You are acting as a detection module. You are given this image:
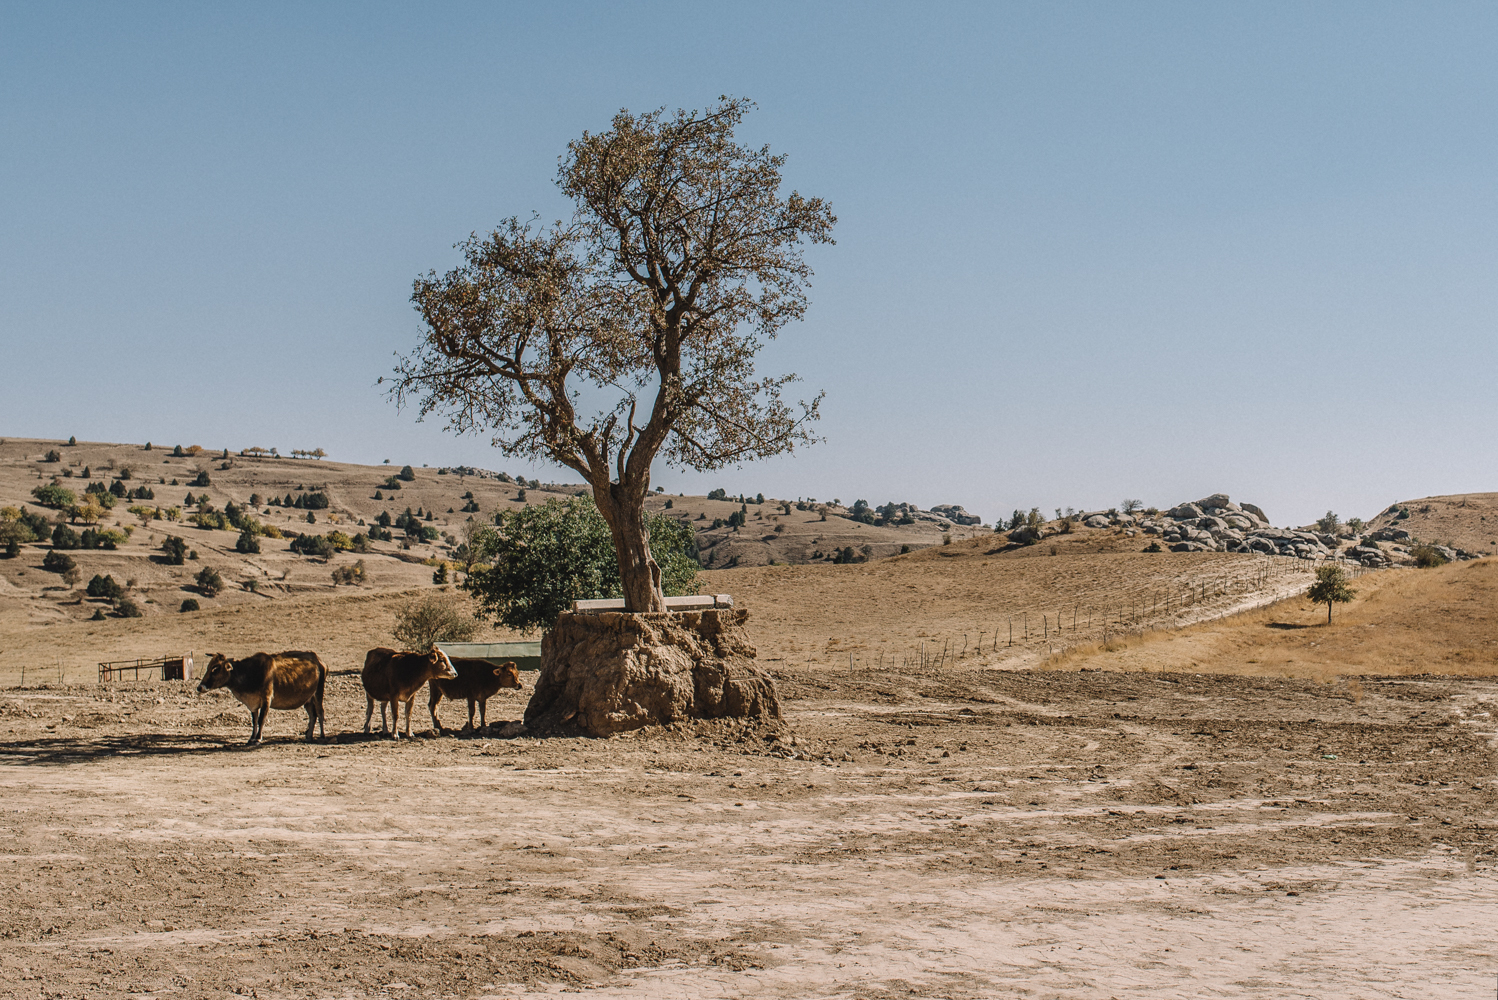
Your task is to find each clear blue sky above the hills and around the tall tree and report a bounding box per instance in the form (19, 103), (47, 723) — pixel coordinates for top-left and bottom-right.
(0, 3), (1498, 524)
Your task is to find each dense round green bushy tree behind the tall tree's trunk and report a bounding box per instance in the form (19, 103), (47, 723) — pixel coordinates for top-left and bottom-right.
(463, 496), (698, 632)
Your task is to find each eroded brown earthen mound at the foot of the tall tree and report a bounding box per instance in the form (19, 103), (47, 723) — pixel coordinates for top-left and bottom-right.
(526, 609), (780, 737)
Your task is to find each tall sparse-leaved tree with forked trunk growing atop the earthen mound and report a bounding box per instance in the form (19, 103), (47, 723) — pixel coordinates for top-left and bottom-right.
(392, 97), (836, 611)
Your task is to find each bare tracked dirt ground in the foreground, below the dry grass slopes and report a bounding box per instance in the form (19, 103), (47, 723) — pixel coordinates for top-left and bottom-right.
(0, 652), (1498, 999)
